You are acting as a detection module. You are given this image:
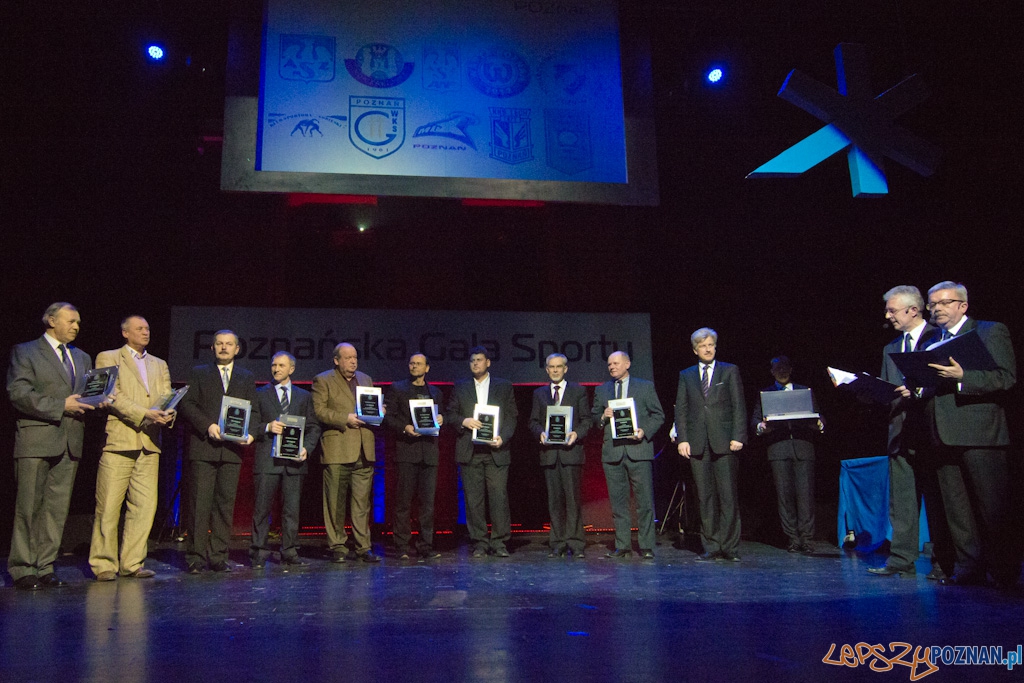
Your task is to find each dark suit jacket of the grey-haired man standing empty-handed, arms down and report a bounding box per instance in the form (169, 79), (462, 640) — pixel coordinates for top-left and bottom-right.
(676, 360), (746, 456)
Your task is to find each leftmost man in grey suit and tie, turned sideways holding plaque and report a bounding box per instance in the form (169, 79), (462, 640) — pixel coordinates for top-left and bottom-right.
(7, 301), (94, 591)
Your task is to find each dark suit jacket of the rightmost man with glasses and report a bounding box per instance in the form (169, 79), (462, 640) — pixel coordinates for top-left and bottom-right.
(926, 318), (1017, 447)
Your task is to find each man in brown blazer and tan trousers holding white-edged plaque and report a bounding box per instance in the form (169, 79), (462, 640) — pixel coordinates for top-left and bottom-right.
(312, 343), (381, 562)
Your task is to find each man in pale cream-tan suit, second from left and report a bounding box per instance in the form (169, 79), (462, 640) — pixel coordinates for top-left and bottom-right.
(89, 315), (174, 581)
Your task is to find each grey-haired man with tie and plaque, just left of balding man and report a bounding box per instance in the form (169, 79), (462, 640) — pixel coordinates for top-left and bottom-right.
(529, 353), (593, 559)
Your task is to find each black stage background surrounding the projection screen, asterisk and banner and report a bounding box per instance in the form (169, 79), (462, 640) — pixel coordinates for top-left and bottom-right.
(0, 0), (1024, 545)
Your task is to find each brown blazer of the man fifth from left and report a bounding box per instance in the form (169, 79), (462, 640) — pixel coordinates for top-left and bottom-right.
(312, 368), (377, 465)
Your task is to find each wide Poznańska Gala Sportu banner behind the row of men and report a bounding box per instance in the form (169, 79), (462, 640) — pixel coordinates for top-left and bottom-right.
(168, 306), (653, 384)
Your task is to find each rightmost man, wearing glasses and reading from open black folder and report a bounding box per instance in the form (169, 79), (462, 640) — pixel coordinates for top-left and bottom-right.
(925, 281), (1020, 585)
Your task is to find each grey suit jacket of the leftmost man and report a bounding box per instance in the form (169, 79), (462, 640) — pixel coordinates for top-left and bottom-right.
(7, 337), (92, 459)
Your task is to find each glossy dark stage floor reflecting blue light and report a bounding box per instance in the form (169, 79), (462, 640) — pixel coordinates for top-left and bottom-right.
(0, 535), (1024, 683)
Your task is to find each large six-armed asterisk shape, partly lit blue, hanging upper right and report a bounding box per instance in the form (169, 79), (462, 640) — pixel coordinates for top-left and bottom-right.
(746, 43), (940, 197)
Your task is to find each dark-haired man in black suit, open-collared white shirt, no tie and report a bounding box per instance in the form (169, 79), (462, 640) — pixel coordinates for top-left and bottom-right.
(445, 346), (519, 557)
